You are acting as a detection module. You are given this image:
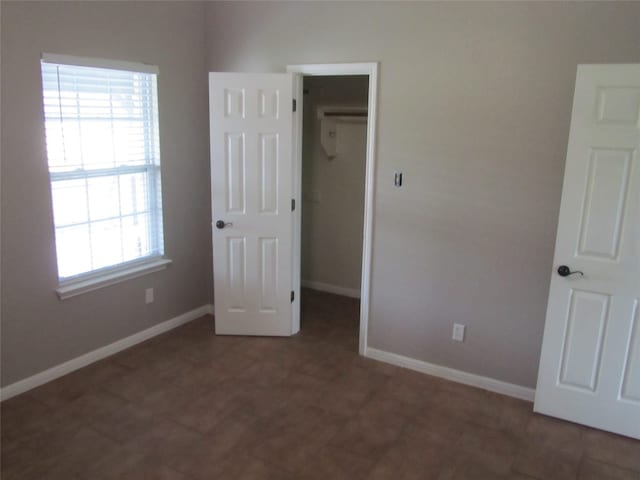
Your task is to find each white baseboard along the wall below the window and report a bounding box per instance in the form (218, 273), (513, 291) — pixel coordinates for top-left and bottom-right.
(0, 304), (213, 401)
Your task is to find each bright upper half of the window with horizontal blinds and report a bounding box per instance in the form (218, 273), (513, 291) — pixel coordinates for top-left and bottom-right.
(42, 62), (159, 172)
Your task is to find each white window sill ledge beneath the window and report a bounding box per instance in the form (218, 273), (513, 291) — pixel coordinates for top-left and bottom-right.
(56, 258), (171, 300)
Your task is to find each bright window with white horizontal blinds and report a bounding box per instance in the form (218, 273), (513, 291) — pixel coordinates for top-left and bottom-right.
(42, 55), (166, 296)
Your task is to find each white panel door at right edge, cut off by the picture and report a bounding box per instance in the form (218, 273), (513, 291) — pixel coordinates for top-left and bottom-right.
(534, 65), (640, 438)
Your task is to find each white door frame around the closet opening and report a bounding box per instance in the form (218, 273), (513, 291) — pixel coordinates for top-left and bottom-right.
(287, 62), (379, 355)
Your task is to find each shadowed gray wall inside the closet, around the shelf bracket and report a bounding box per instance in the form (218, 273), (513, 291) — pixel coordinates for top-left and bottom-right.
(302, 76), (369, 291)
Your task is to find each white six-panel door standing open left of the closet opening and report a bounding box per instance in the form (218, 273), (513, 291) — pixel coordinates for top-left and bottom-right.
(209, 73), (293, 336)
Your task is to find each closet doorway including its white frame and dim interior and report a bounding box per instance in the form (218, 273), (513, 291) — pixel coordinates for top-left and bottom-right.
(287, 63), (378, 355)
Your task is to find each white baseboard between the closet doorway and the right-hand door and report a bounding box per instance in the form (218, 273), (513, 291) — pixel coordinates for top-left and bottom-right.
(365, 347), (535, 402)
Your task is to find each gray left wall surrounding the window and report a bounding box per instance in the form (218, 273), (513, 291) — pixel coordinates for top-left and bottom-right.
(0, 2), (212, 385)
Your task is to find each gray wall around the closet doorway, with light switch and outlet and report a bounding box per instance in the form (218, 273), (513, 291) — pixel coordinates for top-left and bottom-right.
(207, 2), (640, 387)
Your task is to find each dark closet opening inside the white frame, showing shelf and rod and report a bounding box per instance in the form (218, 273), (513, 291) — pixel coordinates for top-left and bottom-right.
(300, 75), (369, 351)
